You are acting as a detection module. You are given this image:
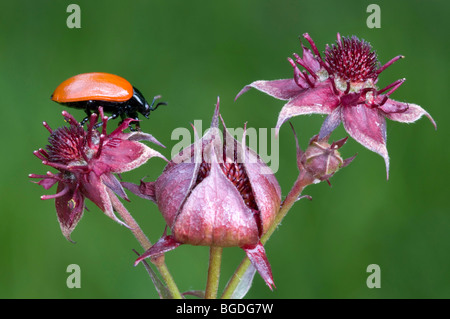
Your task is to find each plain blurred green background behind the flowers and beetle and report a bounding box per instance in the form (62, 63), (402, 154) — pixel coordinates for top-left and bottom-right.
(0, 0), (450, 298)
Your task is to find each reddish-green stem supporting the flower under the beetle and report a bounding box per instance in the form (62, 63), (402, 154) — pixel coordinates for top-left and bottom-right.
(108, 189), (183, 299)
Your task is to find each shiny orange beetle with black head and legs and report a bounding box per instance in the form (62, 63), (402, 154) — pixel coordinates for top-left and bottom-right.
(51, 72), (167, 129)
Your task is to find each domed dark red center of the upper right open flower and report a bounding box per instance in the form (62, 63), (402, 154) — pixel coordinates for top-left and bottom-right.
(325, 36), (378, 82)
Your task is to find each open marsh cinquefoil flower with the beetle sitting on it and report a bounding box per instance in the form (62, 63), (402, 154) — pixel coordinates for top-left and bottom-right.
(29, 108), (164, 241)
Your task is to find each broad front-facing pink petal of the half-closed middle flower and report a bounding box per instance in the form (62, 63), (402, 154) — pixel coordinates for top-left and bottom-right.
(172, 144), (259, 247)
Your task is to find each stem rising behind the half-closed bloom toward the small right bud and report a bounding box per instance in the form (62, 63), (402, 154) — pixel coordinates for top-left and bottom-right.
(221, 171), (314, 299)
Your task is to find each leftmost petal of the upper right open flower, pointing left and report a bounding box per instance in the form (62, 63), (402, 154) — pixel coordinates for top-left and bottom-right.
(235, 79), (304, 100)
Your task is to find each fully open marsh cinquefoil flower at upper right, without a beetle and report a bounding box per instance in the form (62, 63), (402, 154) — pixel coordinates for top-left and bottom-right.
(236, 33), (436, 178)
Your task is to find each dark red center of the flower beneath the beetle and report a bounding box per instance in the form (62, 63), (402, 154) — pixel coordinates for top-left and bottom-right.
(47, 126), (85, 165)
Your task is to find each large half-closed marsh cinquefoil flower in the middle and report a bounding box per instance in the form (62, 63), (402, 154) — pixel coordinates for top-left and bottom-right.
(124, 102), (281, 288)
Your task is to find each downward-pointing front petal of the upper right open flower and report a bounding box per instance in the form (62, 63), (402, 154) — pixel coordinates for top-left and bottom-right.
(342, 104), (388, 177)
